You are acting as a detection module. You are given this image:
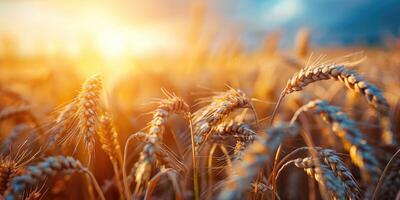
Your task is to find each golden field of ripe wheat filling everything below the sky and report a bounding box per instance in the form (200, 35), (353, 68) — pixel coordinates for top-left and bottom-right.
(0, 0), (400, 200)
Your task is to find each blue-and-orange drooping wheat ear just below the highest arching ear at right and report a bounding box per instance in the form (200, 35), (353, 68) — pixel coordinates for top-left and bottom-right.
(292, 100), (381, 183)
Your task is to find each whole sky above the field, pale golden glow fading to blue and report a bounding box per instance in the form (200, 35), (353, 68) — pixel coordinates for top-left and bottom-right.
(0, 0), (400, 53)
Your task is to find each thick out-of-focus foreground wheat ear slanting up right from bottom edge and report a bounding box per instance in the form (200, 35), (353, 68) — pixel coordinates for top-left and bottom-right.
(217, 123), (298, 200)
